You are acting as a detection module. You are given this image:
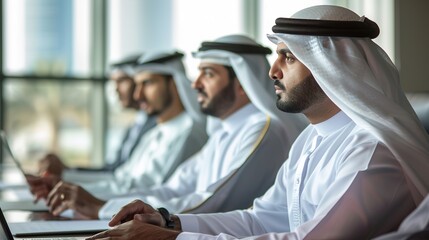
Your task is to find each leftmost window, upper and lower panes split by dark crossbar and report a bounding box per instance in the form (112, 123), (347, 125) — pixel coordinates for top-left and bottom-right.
(1, 0), (104, 172)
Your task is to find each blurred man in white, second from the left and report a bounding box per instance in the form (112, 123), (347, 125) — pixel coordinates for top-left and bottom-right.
(29, 52), (206, 217)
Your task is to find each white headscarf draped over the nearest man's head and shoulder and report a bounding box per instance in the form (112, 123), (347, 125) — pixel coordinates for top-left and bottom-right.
(268, 6), (429, 203)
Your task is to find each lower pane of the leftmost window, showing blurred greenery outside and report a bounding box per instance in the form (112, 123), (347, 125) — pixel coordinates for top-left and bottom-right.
(4, 79), (92, 168)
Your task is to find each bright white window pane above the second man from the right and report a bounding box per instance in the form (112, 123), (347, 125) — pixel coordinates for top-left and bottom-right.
(173, 0), (246, 78)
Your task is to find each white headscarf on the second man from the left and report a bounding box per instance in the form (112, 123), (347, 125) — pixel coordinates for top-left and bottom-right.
(134, 51), (205, 126)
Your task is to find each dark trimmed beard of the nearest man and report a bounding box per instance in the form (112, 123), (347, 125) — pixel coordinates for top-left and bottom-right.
(274, 75), (326, 113)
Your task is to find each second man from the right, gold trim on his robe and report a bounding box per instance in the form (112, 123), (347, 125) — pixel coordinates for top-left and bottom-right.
(42, 35), (305, 219)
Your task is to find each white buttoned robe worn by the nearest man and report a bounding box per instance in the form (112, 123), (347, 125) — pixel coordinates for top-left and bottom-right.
(177, 112), (415, 240)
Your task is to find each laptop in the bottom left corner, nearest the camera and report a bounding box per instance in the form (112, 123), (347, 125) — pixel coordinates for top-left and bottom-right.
(0, 208), (101, 240)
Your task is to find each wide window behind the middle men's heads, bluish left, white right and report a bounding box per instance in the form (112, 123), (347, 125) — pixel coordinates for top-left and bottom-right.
(108, 0), (244, 80)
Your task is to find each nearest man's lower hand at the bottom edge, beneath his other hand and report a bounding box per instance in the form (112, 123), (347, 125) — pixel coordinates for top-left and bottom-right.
(87, 218), (180, 240)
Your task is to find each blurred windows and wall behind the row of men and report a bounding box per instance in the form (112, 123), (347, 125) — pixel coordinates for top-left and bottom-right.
(0, 0), (429, 172)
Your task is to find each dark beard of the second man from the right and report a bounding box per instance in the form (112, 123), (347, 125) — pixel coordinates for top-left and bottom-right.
(200, 79), (235, 117)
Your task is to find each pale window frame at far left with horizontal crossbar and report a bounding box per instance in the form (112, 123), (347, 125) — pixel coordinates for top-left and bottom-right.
(0, 0), (109, 167)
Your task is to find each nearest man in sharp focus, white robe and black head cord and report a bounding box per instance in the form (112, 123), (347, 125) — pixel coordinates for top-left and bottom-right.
(90, 5), (429, 240)
